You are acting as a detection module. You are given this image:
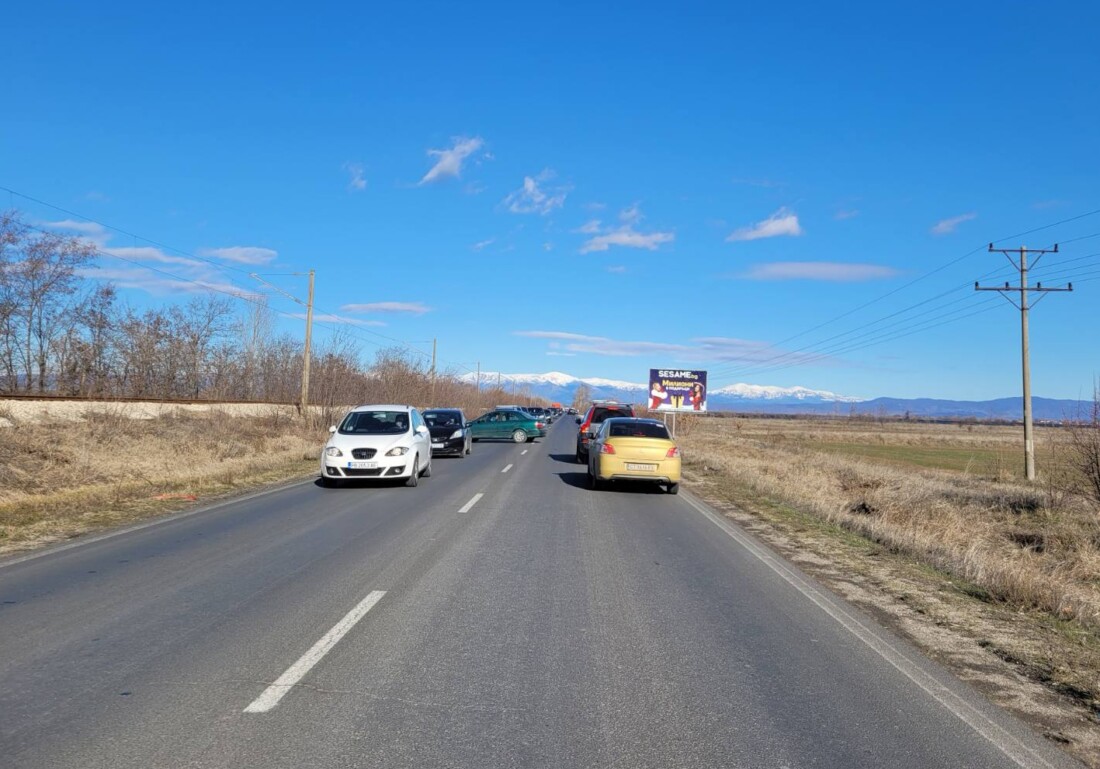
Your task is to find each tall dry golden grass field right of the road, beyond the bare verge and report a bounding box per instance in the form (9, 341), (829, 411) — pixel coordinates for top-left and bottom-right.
(680, 419), (1100, 629)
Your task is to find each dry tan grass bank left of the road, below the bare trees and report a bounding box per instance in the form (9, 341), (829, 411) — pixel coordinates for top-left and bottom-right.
(0, 405), (323, 552)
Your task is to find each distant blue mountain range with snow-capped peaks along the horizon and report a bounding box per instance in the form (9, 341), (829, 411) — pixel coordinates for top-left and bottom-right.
(461, 371), (1092, 421)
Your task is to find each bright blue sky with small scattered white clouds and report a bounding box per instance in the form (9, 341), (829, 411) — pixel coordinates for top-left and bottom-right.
(0, 2), (1100, 398)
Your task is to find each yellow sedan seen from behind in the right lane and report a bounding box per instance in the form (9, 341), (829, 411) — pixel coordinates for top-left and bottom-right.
(589, 417), (680, 494)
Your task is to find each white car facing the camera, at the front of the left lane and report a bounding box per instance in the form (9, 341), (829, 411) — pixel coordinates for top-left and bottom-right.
(321, 405), (431, 486)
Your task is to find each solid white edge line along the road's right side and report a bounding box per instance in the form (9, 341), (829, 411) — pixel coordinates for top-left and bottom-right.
(682, 495), (1055, 769)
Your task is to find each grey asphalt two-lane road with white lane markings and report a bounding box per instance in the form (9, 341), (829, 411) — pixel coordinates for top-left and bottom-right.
(0, 420), (1078, 769)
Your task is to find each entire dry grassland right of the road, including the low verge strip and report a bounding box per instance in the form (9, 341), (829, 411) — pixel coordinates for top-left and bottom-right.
(678, 409), (1100, 765)
